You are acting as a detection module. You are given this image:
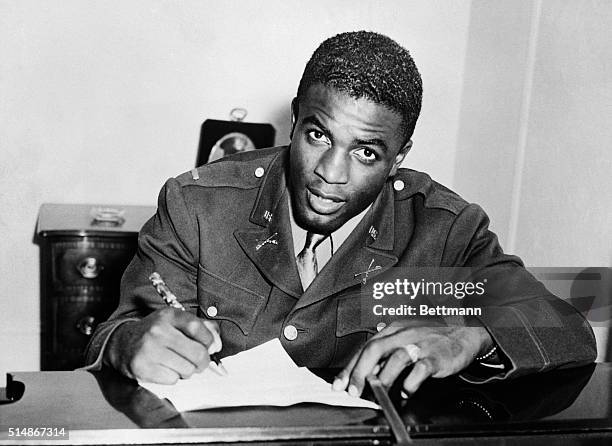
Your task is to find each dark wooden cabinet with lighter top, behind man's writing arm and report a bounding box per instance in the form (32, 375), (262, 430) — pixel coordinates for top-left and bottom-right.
(37, 204), (155, 370)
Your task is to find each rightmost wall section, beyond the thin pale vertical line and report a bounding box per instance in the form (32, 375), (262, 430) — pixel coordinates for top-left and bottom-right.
(514, 1), (612, 266)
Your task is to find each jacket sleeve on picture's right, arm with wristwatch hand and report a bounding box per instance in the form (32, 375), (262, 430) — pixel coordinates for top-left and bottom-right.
(443, 204), (597, 381)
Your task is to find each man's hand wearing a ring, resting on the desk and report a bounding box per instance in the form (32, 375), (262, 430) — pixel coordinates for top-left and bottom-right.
(333, 323), (493, 396)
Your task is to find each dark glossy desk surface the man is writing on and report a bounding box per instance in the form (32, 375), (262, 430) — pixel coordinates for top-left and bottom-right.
(0, 364), (612, 444)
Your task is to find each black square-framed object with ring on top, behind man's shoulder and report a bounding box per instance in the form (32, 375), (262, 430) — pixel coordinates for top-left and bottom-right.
(196, 108), (276, 167)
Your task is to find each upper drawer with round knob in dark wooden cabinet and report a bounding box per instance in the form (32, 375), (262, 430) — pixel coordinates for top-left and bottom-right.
(51, 240), (136, 291)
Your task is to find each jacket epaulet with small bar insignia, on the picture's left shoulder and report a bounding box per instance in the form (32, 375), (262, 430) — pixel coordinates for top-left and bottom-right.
(176, 147), (285, 189)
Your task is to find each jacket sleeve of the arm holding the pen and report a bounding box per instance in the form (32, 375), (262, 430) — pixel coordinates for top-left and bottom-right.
(85, 179), (199, 370)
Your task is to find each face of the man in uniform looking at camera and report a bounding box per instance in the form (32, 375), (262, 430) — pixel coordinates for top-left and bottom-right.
(290, 84), (412, 234)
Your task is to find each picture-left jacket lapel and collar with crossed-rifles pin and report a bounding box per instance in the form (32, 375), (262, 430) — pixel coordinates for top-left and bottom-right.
(234, 151), (302, 299)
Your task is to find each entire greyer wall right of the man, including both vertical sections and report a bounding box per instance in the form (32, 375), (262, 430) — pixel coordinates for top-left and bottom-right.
(454, 0), (612, 360)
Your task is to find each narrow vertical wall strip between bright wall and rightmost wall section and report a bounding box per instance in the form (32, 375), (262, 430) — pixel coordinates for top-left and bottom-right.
(453, 0), (533, 247)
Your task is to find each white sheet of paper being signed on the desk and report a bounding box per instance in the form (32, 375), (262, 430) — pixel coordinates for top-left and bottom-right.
(140, 339), (379, 412)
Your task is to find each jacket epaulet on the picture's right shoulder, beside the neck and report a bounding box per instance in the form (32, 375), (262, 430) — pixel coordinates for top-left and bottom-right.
(393, 169), (468, 214)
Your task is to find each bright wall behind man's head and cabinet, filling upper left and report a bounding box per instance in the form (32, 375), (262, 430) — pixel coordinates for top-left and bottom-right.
(0, 0), (470, 377)
